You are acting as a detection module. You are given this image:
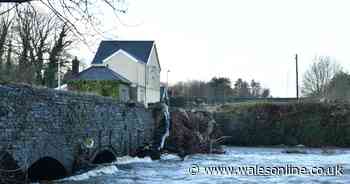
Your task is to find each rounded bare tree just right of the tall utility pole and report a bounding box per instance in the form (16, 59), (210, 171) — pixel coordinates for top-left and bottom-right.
(302, 56), (341, 97)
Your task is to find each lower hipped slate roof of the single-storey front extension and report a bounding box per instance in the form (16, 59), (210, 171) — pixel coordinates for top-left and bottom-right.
(71, 66), (131, 83)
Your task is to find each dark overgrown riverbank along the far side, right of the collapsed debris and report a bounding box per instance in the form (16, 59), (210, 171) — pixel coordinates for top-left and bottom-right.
(215, 103), (350, 147)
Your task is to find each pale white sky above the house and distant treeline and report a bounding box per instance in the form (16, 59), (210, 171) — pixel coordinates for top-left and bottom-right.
(73, 0), (350, 97)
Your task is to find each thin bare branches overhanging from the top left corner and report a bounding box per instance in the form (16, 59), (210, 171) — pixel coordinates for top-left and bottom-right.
(0, 0), (127, 42)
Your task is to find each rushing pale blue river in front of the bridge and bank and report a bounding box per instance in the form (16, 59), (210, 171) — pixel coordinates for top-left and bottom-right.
(54, 147), (350, 184)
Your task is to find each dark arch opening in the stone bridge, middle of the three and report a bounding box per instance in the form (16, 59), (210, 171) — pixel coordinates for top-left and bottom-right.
(27, 157), (67, 182)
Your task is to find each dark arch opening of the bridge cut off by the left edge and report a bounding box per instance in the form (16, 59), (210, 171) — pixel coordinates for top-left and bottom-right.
(0, 151), (25, 183)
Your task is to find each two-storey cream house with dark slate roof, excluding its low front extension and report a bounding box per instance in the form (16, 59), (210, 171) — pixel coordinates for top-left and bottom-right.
(91, 41), (161, 105)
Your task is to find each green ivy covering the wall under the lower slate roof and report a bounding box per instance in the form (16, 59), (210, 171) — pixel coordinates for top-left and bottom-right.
(68, 80), (120, 99)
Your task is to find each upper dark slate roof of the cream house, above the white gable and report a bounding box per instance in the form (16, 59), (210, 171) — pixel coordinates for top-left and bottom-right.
(91, 41), (154, 64)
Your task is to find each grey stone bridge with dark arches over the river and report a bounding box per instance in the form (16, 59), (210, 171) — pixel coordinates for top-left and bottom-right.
(0, 84), (154, 183)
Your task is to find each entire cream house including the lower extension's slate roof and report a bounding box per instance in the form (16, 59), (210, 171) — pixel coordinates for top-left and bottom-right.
(68, 41), (161, 105)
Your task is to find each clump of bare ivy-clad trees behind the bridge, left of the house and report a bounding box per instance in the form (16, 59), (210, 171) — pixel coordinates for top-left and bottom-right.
(0, 7), (75, 87)
